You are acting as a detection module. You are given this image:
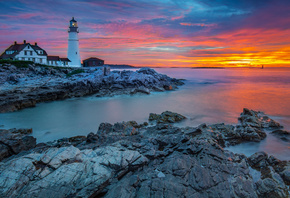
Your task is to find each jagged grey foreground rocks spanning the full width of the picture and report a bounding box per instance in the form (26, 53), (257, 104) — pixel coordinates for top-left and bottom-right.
(0, 109), (290, 198)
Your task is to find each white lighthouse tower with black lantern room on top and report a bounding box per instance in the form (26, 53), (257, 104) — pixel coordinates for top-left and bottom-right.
(67, 17), (81, 67)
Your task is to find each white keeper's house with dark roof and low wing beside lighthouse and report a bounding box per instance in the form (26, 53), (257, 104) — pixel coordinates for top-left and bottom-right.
(0, 40), (70, 66)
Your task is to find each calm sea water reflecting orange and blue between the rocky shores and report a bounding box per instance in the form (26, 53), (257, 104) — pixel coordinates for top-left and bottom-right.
(0, 68), (290, 160)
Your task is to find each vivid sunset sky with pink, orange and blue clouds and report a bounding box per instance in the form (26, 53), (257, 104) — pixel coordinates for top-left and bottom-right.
(0, 0), (290, 67)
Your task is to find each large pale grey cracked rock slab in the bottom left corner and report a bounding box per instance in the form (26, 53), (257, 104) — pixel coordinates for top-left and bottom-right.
(0, 146), (148, 197)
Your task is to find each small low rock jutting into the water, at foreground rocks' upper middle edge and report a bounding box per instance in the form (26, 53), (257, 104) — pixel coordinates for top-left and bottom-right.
(149, 111), (186, 123)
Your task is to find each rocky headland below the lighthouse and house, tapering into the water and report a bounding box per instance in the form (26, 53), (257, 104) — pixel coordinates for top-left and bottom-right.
(0, 63), (184, 113)
